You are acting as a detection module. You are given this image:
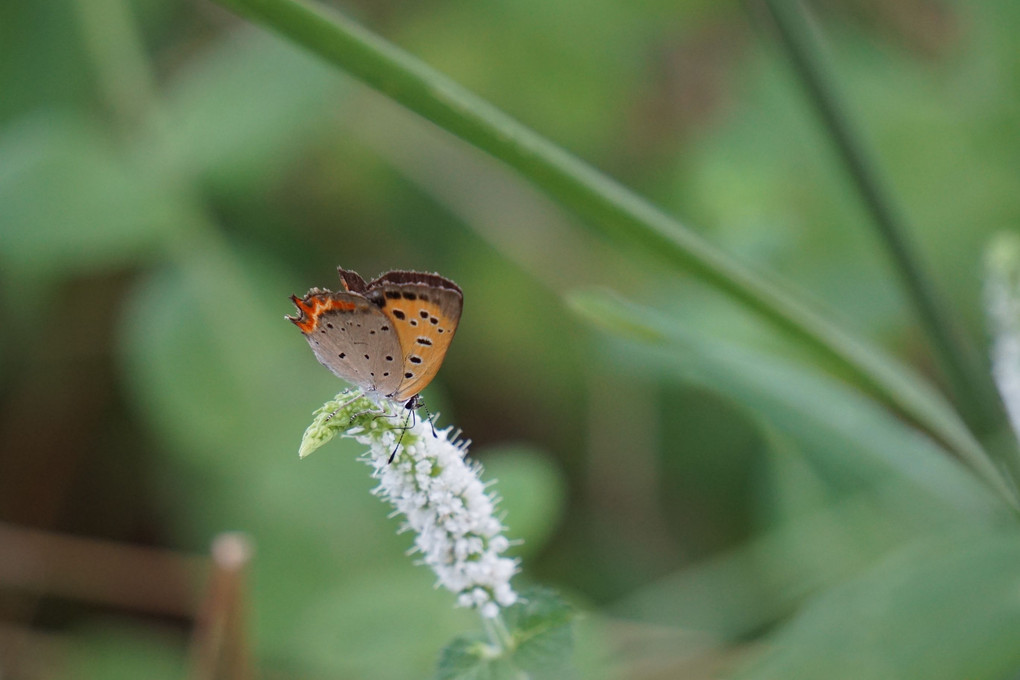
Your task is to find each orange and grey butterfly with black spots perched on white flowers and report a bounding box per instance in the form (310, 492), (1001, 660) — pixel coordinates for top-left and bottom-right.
(286, 267), (464, 410)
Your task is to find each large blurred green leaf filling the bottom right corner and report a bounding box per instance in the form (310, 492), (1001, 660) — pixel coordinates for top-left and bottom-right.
(736, 531), (1020, 680)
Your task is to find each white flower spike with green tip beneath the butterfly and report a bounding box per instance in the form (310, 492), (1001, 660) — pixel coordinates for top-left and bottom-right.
(299, 390), (517, 619)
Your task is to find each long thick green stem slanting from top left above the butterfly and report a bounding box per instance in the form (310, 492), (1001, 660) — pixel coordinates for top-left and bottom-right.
(216, 0), (1015, 503)
